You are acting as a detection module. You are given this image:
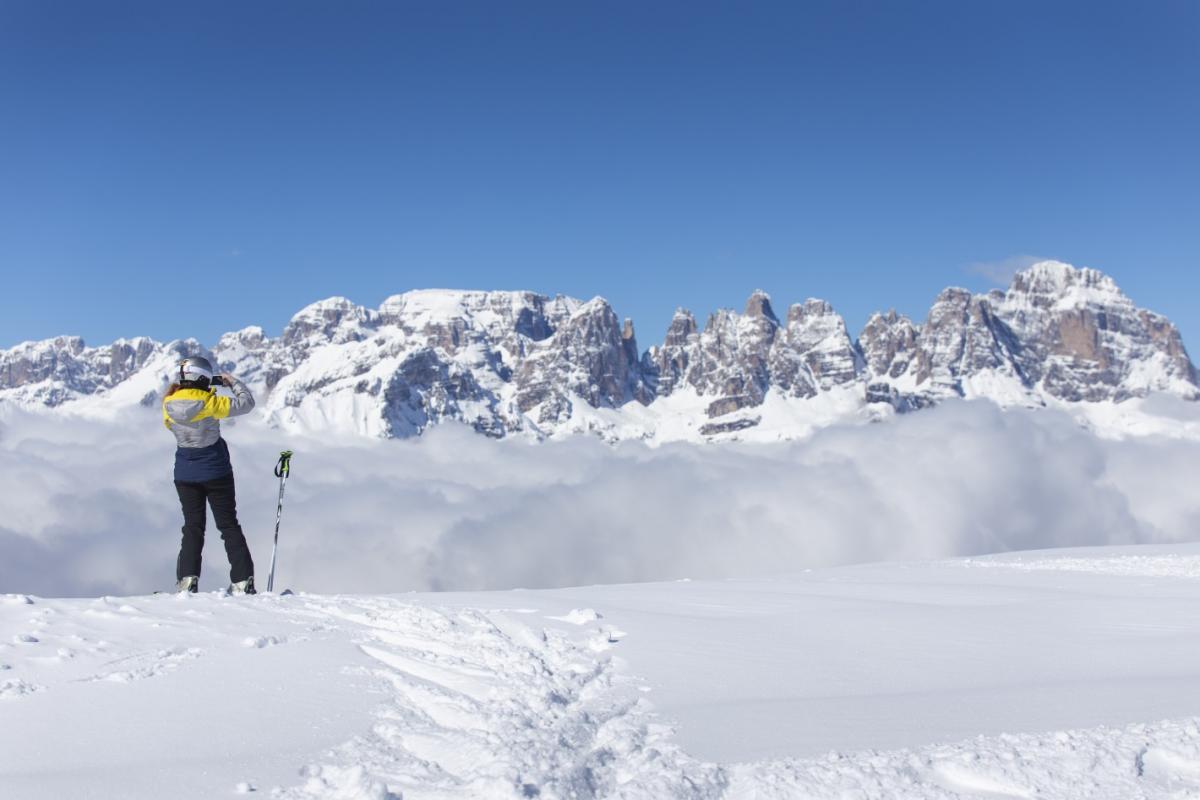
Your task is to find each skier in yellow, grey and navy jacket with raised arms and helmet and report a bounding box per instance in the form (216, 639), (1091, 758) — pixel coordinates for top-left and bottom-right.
(162, 356), (256, 595)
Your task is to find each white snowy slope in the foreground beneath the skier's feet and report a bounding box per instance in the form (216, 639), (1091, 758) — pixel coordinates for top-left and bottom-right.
(7, 546), (1200, 800)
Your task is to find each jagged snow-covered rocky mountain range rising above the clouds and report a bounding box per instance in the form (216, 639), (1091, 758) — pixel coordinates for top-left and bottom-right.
(0, 261), (1200, 440)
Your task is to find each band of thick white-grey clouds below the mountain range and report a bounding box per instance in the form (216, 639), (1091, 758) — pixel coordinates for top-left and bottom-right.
(0, 402), (1200, 596)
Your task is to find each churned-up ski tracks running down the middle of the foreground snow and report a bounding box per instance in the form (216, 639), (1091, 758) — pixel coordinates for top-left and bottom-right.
(281, 597), (725, 800)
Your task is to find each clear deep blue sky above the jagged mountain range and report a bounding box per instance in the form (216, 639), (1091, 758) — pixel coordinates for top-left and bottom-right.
(0, 0), (1200, 355)
